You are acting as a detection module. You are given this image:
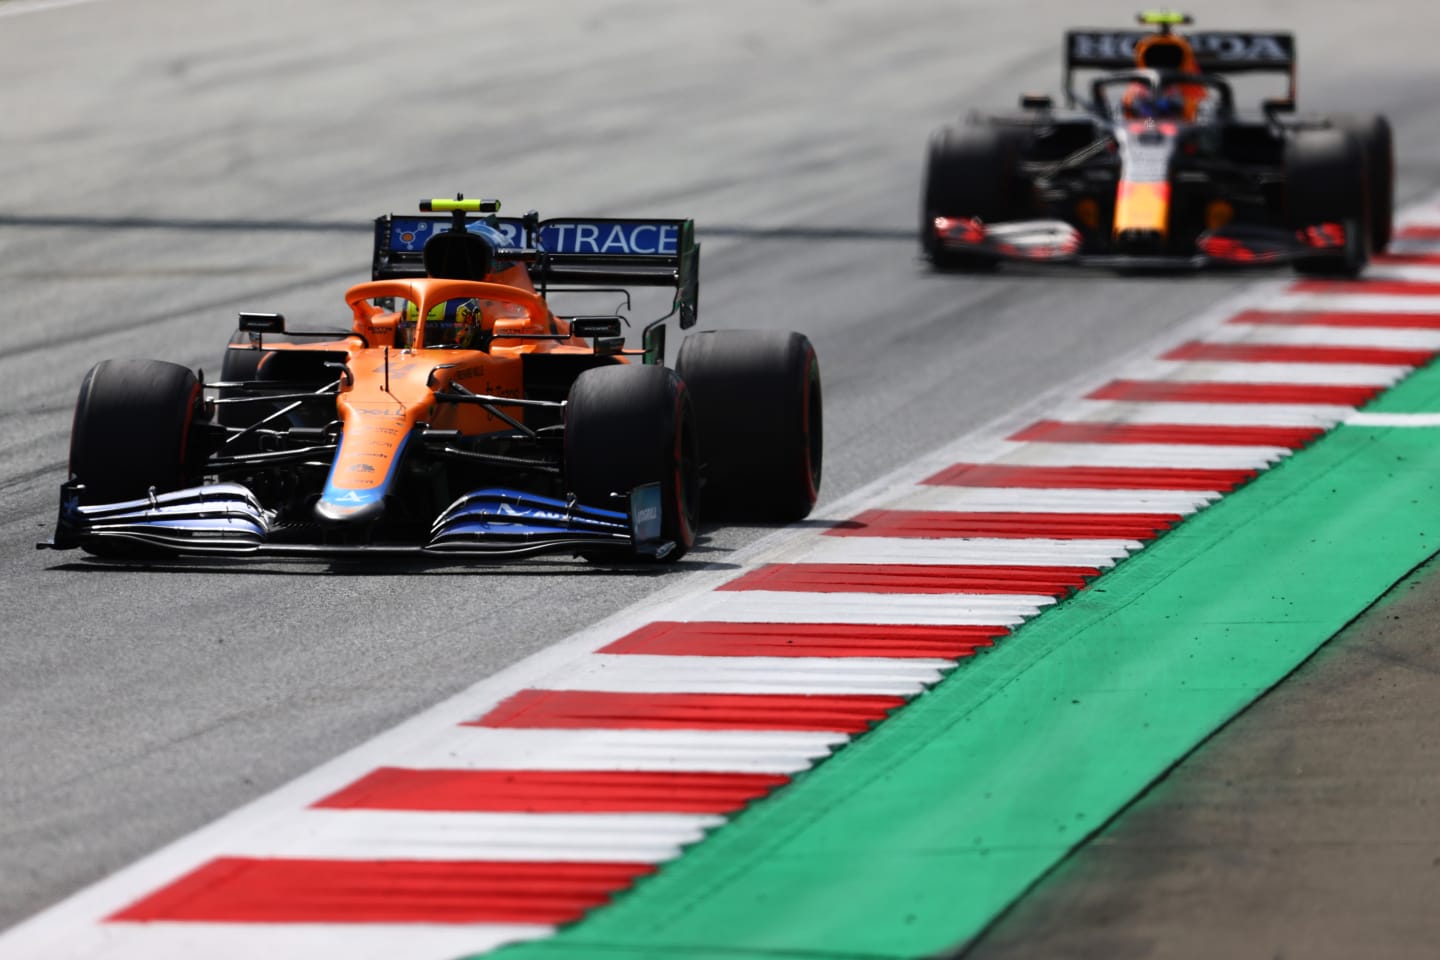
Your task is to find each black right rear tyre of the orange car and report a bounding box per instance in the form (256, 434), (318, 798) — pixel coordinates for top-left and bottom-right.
(675, 330), (824, 522)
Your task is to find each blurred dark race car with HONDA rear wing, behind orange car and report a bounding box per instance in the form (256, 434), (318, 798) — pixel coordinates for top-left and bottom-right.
(920, 13), (1394, 275)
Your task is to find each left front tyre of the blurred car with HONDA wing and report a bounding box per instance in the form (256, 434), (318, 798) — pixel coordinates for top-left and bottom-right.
(920, 124), (1022, 271)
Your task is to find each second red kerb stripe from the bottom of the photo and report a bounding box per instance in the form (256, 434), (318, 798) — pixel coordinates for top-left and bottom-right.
(315, 767), (789, 813)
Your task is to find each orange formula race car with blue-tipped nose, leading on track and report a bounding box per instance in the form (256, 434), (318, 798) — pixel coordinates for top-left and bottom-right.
(42, 197), (821, 560)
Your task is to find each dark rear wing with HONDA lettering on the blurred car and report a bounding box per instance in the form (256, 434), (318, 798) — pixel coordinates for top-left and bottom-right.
(1064, 30), (1295, 105)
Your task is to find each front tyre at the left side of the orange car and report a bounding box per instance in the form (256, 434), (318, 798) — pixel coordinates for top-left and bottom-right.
(71, 360), (204, 504)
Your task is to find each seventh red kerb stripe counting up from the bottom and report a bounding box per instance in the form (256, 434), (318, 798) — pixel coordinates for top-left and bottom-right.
(924, 463), (1256, 491)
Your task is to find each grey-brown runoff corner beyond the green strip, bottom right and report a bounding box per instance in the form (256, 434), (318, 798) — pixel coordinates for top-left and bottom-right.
(955, 561), (1440, 960)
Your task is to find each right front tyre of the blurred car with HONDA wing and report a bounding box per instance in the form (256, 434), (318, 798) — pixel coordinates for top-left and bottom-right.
(1284, 127), (1371, 276)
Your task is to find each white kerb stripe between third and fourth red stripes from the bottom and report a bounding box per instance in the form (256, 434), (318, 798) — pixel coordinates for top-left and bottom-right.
(539, 653), (953, 697)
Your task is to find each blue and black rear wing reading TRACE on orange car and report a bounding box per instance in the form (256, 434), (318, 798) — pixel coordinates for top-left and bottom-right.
(370, 213), (700, 327)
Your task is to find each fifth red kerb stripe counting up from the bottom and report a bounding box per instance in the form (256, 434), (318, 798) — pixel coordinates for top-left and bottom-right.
(717, 563), (1100, 597)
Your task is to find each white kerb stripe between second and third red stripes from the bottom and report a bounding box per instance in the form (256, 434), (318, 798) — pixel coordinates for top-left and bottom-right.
(392, 727), (850, 773)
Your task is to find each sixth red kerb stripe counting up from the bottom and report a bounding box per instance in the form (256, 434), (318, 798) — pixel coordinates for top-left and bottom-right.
(825, 510), (1181, 540)
